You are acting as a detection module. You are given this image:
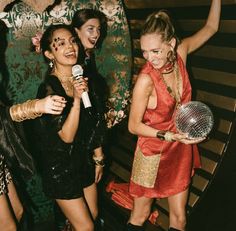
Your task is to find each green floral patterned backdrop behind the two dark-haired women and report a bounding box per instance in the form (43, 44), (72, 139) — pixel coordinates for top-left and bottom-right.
(0, 0), (131, 222)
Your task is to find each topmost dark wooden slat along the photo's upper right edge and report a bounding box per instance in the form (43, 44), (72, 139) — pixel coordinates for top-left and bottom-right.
(124, 0), (235, 9)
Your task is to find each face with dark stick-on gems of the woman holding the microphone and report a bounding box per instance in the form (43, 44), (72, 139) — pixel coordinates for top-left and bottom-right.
(45, 28), (78, 67)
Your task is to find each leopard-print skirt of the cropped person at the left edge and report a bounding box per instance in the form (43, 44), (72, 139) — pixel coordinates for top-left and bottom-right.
(0, 154), (12, 195)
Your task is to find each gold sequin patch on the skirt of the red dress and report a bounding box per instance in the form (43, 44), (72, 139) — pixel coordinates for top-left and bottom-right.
(131, 148), (161, 188)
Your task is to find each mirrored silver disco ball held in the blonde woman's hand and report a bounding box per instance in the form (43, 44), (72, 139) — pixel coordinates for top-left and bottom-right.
(175, 101), (214, 139)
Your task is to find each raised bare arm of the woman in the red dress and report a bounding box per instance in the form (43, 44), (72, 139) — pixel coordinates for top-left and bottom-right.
(177, 0), (221, 61)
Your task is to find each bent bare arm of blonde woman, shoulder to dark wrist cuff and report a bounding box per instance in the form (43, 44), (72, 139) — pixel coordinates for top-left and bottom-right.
(128, 74), (157, 137)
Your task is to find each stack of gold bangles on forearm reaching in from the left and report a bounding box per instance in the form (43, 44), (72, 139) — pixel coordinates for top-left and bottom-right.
(10, 99), (42, 122)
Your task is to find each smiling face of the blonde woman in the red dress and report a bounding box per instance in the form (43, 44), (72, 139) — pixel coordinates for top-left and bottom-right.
(140, 33), (175, 69)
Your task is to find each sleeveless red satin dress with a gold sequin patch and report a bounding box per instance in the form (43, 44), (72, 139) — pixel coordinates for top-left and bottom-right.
(129, 56), (200, 198)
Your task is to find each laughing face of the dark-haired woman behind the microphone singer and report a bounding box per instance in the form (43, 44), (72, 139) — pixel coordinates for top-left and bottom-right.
(75, 18), (101, 49)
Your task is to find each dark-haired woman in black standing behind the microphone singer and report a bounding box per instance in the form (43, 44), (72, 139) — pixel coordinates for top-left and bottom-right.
(71, 9), (108, 227)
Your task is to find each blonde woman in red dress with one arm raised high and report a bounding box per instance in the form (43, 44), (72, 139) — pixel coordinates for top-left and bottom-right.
(127, 0), (221, 231)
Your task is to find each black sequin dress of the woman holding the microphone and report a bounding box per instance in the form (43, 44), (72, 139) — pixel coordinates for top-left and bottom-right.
(34, 75), (106, 199)
